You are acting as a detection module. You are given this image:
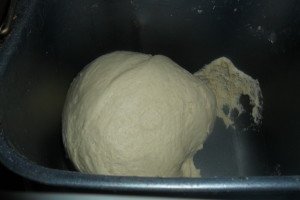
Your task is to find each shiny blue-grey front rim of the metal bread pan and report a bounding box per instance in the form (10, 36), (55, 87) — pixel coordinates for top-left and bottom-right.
(0, 133), (300, 197)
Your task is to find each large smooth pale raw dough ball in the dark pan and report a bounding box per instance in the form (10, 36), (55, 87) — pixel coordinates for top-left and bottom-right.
(63, 51), (216, 177)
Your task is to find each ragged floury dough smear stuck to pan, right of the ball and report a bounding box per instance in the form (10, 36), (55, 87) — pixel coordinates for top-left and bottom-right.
(194, 57), (262, 128)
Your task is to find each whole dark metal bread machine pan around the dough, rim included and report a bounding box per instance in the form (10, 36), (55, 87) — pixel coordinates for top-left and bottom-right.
(0, 0), (300, 197)
